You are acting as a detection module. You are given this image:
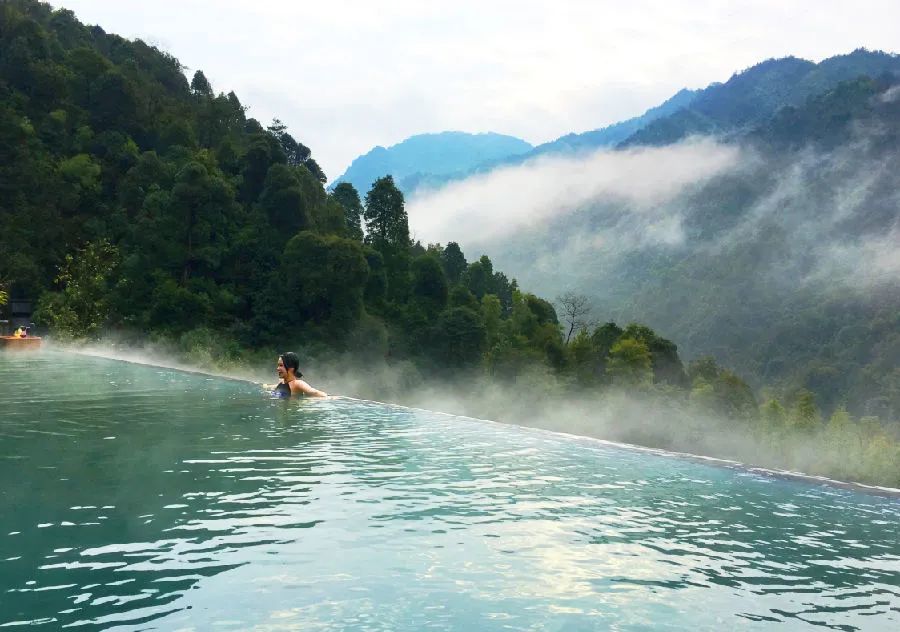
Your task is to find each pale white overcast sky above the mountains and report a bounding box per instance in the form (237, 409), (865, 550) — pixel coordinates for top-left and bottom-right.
(51, 0), (900, 178)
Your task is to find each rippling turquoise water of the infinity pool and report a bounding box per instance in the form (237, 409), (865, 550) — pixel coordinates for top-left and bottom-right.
(0, 352), (900, 630)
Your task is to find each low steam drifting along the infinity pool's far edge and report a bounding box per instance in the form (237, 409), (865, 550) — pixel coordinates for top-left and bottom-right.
(44, 342), (900, 494)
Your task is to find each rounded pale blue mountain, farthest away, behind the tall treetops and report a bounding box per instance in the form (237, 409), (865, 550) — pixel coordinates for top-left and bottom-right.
(331, 132), (533, 195)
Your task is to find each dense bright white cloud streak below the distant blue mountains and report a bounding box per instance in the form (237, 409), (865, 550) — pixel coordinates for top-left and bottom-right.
(408, 138), (742, 246)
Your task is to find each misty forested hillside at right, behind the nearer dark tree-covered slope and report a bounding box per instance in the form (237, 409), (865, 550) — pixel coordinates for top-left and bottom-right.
(487, 75), (900, 418)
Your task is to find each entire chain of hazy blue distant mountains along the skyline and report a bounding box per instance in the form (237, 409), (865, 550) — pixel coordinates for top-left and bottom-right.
(335, 48), (900, 195)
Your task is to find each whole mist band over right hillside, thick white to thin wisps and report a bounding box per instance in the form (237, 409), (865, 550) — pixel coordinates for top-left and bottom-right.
(409, 129), (900, 298)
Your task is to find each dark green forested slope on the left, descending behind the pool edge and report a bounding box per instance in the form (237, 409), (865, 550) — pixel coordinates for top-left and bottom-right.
(0, 0), (900, 486)
